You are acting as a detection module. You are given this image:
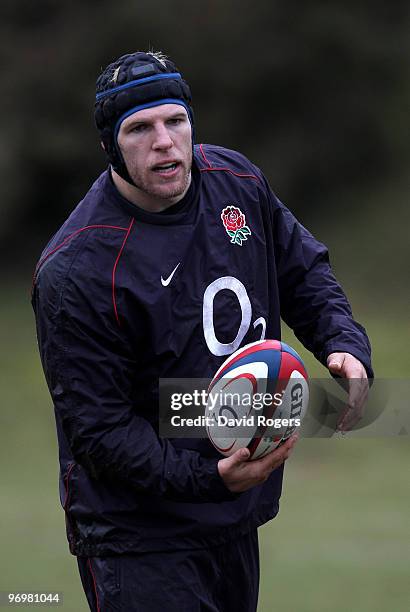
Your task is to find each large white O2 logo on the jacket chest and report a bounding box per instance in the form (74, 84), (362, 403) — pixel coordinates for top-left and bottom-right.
(202, 276), (266, 357)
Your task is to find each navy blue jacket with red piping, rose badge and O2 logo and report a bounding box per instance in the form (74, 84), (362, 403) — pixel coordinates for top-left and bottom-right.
(33, 145), (371, 556)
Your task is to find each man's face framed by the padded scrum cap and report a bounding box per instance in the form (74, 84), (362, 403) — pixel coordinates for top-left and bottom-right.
(117, 104), (192, 204)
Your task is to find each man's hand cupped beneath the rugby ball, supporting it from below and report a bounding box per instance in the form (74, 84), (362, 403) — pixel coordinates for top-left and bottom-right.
(218, 434), (298, 493)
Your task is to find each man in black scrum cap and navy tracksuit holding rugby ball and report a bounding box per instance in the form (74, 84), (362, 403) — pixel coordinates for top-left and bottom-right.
(33, 52), (372, 612)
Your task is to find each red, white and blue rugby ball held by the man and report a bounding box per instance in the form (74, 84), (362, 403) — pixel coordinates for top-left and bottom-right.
(206, 340), (309, 459)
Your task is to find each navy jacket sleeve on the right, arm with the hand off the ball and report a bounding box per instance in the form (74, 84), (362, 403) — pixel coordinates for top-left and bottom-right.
(270, 186), (373, 378)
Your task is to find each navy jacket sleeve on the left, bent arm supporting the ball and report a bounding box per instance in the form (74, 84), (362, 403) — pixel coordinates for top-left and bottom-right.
(33, 271), (238, 502)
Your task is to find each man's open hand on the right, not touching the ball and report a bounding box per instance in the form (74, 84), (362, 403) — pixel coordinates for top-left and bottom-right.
(327, 353), (369, 431)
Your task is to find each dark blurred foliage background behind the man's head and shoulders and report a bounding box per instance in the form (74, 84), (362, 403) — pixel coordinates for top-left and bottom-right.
(0, 0), (410, 275)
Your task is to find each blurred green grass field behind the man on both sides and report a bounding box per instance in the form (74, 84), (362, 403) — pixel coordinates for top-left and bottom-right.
(0, 288), (410, 612)
